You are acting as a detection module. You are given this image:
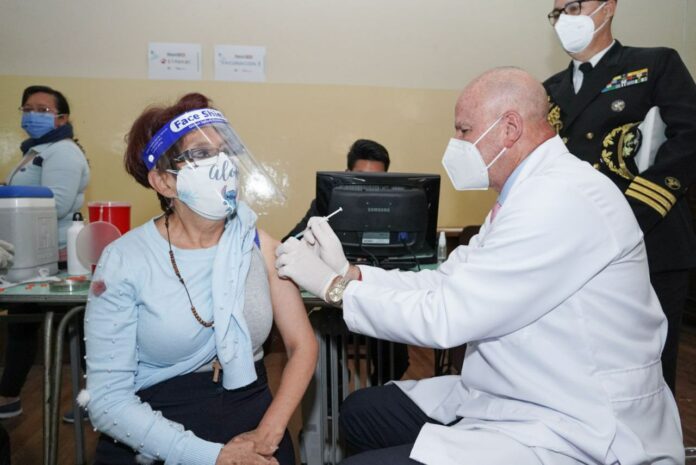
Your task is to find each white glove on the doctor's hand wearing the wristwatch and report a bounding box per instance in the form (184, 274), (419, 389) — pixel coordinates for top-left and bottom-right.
(275, 237), (338, 300)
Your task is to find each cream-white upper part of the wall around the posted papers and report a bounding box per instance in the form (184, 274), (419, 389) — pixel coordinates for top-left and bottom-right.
(0, 0), (696, 89)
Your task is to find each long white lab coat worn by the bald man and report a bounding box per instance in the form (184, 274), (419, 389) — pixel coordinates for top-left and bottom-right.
(343, 137), (684, 465)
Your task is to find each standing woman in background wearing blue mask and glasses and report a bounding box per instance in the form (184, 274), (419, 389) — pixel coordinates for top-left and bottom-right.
(0, 86), (89, 418)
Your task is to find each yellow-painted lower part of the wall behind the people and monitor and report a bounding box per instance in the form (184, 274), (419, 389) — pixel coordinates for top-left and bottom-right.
(0, 76), (495, 237)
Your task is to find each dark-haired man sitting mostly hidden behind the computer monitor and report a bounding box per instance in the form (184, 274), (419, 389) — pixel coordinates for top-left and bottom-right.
(283, 139), (408, 384)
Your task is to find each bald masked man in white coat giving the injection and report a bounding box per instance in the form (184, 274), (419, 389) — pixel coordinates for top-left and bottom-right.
(276, 68), (684, 465)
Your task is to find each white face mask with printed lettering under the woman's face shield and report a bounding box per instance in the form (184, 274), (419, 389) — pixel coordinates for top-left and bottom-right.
(170, 152), (238, 220)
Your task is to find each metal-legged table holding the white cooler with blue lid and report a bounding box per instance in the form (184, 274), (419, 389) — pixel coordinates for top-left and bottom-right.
(0, 283), (87, 465)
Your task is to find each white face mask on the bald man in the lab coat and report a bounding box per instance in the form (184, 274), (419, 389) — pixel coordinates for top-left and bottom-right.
(442, 115), (507, 191)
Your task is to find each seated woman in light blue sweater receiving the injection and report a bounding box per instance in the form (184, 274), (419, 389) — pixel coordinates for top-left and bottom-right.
(80, 94), (317, 465)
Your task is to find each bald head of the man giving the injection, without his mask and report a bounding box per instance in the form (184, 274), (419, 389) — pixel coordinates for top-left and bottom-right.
(455, 67), (555, 191)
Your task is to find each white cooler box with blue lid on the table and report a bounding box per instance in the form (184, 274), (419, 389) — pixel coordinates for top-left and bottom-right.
(0, 186), (58, 282)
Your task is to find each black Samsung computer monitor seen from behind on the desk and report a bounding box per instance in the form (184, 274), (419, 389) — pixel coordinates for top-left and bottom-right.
(316, 171), (440, 268)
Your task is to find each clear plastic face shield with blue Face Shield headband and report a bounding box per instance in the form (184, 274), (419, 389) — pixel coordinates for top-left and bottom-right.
(143, 108), (286, 214)
